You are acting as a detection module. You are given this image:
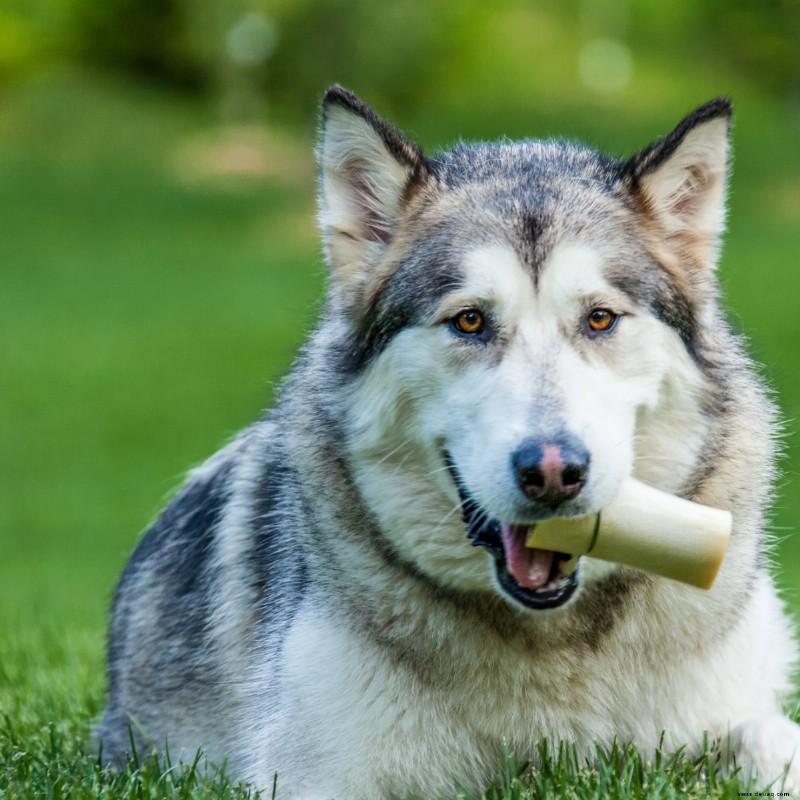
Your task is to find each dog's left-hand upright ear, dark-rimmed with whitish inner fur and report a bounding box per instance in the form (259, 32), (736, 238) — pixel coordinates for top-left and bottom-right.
(317, 86), (427, 284)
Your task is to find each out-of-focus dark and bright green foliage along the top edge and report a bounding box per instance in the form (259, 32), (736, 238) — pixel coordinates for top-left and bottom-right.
(0, 0), (800, 117)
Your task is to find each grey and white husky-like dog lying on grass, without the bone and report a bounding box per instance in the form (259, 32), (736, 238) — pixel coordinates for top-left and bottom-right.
(97, 87), (800, 800)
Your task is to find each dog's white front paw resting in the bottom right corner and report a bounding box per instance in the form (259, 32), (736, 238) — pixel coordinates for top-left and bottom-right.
(730, 714), (800, 797)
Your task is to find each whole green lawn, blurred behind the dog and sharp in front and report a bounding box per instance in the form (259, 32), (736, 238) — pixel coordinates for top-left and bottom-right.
(0, 65), (800, 800)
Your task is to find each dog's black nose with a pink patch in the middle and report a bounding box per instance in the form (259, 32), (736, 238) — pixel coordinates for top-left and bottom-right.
(511, 434), (589, 509)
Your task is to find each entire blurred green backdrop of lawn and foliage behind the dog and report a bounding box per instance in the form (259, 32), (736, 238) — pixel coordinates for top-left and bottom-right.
(0, 0), (800, 713)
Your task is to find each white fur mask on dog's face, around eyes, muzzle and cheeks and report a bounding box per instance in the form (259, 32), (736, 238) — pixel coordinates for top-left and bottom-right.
(349, 243), (703, 589)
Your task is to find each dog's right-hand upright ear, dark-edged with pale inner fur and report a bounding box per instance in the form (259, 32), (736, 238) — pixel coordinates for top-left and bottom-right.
(622, 97), (732, 268)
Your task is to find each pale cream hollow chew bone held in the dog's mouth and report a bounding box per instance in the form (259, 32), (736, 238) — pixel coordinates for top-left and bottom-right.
(526, 478), (732, 589)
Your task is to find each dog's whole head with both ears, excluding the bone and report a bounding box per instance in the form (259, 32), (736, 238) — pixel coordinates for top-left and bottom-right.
(320, 89), (730, 609)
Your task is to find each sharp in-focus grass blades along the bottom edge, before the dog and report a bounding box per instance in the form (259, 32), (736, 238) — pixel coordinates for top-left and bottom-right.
(0, 717), (778, 800)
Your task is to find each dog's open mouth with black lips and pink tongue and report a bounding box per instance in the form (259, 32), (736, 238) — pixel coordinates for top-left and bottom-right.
(444, 452), (578, 609)
